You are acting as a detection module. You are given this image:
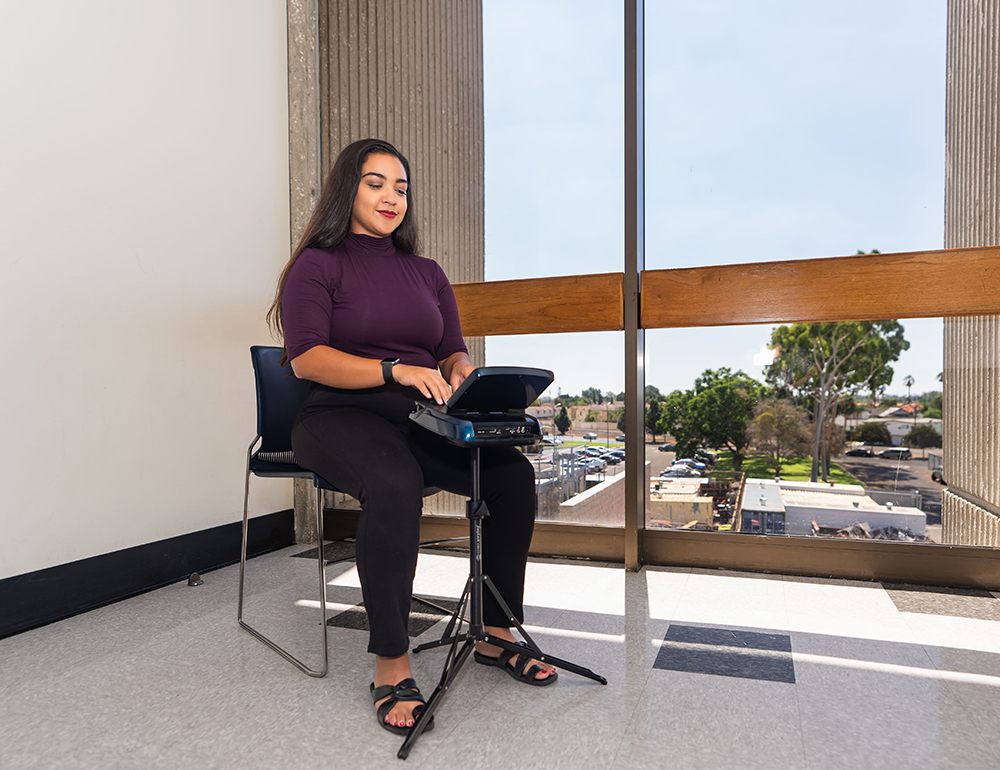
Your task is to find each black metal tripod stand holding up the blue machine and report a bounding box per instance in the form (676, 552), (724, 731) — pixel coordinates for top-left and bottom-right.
(396, 446), (608, 759)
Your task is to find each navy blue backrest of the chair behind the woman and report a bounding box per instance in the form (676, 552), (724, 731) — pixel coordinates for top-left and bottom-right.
(250, 345), (309, 452)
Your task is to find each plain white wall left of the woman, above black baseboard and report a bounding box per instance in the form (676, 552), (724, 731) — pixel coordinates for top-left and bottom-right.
(0, 0), (291, 578)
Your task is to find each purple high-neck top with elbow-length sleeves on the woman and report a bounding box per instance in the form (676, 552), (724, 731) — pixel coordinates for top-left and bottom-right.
(281, 233), (468, 369)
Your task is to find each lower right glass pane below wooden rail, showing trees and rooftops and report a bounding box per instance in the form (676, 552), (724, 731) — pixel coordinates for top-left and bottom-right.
(647, 319), (944, 543)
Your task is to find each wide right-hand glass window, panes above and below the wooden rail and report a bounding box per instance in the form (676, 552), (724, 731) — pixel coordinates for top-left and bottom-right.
(645, 0), (964, 542)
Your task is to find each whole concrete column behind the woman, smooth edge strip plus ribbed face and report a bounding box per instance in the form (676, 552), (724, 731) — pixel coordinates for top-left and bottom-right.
(286, 0), (486, 542)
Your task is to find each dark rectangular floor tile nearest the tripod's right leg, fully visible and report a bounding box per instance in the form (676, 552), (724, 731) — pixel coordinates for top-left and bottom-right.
(653, 623), (795, 684)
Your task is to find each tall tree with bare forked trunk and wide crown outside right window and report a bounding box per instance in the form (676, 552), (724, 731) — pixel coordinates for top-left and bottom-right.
(766, 321), (910, 481)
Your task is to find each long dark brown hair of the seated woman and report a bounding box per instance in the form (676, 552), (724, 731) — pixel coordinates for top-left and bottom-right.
(267, 139), (420, 337)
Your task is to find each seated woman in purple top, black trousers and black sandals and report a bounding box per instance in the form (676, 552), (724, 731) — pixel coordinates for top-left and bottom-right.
(268, 139), (556, 733)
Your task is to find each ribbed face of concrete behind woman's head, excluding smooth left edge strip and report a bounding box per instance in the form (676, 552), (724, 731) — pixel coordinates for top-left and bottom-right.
(319, 0), (486, 282)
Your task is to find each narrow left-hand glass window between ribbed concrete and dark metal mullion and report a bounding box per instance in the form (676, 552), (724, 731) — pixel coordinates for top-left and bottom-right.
(483, 0), (625, 526)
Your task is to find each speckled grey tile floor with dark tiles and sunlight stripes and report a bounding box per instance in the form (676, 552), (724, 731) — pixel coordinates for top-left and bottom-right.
(0, 547), (1000, 770)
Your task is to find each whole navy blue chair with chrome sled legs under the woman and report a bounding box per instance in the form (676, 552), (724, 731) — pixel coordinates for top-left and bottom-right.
(237, 345), (454, 677)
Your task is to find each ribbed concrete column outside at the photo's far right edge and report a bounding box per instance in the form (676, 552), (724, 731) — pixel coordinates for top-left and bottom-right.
(942, 0), (1000, 545)
